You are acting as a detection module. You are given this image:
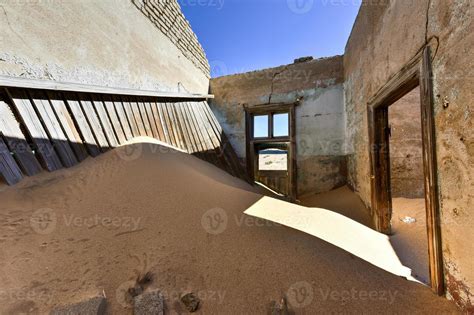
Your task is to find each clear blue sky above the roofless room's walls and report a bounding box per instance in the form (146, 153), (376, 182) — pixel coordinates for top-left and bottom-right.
(178, 0), (362, 77)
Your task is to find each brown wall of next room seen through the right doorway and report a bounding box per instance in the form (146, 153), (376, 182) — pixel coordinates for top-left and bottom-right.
(388, 88), (425, 198)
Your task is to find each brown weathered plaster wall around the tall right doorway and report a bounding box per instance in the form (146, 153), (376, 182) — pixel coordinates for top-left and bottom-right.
(344, 0), (474, 312)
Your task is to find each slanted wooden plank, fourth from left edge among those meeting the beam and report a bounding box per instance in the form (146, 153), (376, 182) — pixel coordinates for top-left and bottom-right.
(47, 92), (88, 161)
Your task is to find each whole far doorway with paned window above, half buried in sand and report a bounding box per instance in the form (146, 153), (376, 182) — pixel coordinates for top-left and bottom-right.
(245, 104), (296, 200)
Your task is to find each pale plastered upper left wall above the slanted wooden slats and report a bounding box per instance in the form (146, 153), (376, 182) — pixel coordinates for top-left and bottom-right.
(0, 0), (209, 93)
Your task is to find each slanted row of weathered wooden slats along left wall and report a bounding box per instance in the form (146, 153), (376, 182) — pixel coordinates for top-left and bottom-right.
(0, 88), (246, 185)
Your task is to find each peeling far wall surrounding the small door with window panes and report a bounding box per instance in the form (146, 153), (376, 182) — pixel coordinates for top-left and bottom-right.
(210, 56), (346, 195)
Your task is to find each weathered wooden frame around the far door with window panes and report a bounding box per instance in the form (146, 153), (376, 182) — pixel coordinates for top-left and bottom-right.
(244, 102), (298, 201)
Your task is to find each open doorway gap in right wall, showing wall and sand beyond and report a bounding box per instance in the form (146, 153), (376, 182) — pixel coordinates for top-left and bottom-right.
(388, 87), (430, 285)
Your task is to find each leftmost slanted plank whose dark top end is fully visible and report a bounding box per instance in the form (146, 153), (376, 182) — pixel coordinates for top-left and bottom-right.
(8, 90), (63, 172)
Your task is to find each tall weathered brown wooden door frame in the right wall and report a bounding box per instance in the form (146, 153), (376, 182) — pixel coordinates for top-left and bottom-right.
(367, 46), (444, 295)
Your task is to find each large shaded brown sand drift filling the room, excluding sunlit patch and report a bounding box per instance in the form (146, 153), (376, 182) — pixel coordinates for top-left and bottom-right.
(0, 144), (457, 314)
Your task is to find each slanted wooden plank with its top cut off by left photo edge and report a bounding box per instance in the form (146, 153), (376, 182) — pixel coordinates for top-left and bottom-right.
(0, 100), (41, 176)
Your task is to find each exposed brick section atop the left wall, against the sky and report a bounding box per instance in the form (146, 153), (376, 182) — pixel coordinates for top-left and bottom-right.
(131, 0), (210, 78)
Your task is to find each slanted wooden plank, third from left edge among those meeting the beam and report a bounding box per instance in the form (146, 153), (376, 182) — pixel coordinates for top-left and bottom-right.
(30, 91), (78, 167)
